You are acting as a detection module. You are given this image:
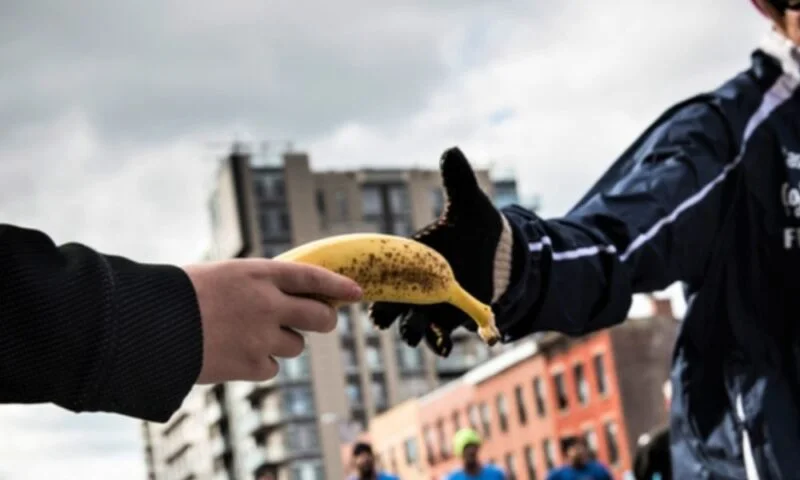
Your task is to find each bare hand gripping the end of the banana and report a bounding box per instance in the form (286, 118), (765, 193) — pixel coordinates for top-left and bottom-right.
(185, 259), (361, 383)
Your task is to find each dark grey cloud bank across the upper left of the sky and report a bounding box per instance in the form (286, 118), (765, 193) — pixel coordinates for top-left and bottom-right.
(0, 0), (552, 146)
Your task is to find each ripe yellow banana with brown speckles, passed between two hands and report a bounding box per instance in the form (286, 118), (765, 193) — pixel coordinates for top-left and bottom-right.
(275, 233), (500, 345)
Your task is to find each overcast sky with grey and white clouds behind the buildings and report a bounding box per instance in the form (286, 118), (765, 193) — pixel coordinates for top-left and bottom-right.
(0, 0), (766, 480)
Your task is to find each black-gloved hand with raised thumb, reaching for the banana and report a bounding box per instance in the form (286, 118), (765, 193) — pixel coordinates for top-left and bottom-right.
(369, 148), (513, 357)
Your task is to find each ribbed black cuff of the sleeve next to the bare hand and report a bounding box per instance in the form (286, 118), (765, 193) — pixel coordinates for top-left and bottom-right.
(87, 256), (203, 422)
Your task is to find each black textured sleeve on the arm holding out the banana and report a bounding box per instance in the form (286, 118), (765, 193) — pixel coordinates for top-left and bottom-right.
(0, 224), (203, 422)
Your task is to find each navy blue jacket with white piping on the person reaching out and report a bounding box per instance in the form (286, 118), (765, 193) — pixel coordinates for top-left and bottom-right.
(497, 34), (800, 480)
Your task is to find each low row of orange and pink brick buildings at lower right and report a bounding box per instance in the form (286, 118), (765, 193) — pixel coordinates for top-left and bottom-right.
(340, 301), (678, 480)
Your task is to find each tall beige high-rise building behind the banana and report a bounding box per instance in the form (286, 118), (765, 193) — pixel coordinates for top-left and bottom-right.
(145, 143), (536, 480)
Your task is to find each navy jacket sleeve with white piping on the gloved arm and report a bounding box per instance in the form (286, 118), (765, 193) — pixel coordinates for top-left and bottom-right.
(496, 102), (738, 341)
